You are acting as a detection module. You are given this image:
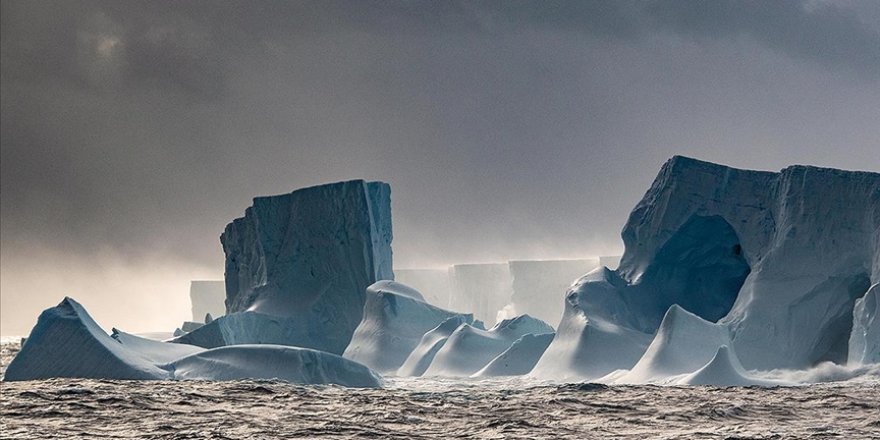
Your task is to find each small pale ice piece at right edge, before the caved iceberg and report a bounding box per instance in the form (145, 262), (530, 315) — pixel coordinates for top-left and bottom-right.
(847, 284), (880, 364)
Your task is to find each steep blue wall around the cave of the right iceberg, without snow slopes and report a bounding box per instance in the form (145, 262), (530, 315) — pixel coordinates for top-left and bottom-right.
(618, 156), (880, 369)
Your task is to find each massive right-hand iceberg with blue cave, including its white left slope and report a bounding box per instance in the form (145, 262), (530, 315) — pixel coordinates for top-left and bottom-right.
(534, 156), (880, 379)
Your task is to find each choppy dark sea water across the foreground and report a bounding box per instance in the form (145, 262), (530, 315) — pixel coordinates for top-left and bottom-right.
(0, 344), (880, 439)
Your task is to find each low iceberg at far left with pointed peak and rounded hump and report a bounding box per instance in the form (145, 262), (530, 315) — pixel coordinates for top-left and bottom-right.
(4, 298), (381, 387)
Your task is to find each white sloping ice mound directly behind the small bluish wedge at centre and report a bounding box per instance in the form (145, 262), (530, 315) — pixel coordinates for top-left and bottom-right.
(424, 315), (553, 377)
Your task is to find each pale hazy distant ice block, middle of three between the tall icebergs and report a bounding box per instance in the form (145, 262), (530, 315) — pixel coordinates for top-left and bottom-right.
(449, 263), (512, 323)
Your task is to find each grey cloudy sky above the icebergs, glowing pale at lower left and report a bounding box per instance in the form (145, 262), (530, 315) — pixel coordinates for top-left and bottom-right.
(0, 0), (880, 335)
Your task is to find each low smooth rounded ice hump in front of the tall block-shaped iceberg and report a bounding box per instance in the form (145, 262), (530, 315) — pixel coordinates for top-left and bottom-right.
(165, 344), (381, 388)
